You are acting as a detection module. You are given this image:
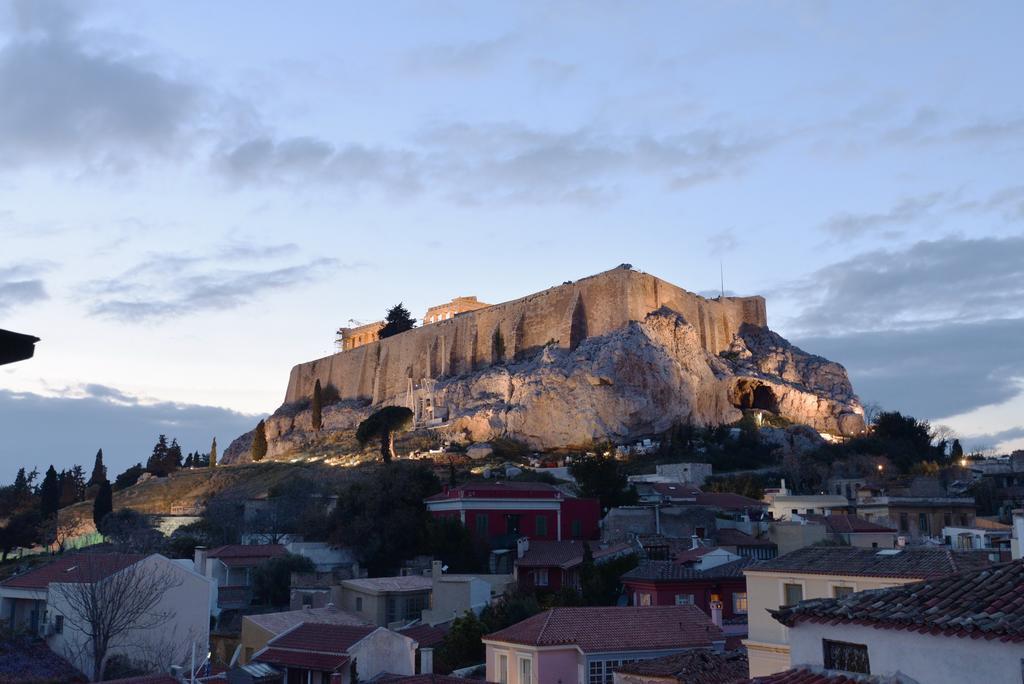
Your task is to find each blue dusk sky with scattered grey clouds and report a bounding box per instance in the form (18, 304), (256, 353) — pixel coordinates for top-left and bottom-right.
(0, 0), (1024, 481)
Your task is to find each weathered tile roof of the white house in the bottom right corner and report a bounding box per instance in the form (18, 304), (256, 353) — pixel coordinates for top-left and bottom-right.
(772, 561), (1024, 641)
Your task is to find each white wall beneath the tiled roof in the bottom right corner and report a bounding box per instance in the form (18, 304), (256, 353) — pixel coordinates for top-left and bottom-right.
(790, 623), (1024, 684)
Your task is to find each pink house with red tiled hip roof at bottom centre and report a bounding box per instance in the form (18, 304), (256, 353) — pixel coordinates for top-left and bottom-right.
(483, 605), (725, 684)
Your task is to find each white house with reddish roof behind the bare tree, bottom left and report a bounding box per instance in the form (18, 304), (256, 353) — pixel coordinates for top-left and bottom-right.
(0, 553), (213, 675)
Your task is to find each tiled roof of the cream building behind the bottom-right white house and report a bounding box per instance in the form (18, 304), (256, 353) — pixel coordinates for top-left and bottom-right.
(749, 546), (991, 580)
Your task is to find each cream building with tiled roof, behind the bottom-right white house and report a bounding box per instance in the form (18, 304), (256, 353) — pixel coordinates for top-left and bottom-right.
(743, 546), (990, 677)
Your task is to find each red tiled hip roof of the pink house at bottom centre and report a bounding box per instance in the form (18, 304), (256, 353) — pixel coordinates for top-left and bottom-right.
(484, 605), (724, 653)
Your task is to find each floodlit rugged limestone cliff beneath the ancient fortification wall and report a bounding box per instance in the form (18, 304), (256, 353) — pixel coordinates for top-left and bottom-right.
(224, 306), (863, 462)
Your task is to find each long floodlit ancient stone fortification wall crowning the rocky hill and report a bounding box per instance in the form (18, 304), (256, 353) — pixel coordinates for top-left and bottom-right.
(285, 267), (768, 404)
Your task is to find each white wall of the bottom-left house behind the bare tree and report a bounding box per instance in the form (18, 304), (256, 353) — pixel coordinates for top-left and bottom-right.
(46, 554), (213, 674)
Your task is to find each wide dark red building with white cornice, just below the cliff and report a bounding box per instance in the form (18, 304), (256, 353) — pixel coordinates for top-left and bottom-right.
(425, 481), (601, 547)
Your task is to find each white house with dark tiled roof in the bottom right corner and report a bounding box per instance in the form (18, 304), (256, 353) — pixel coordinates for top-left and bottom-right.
(772, 562), (1024, 684)
